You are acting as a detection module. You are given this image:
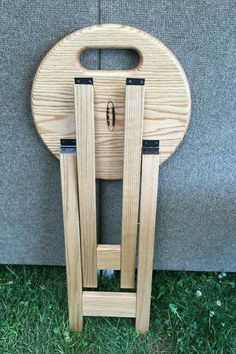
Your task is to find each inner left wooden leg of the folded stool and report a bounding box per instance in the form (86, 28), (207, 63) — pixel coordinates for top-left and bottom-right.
(74, 79), (97, 287)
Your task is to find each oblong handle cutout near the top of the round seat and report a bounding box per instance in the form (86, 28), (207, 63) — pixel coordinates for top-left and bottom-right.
(79, 48), (140, 70)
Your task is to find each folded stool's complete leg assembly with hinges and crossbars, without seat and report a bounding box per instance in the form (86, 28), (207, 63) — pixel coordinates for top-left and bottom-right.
(60, 78), (159, 333)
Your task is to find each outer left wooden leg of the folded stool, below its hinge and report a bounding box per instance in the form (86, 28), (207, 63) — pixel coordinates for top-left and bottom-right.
(60, 154), (83, 332)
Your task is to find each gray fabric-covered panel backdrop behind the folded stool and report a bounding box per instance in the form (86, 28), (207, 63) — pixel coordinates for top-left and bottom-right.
(0, 0), (236, 271)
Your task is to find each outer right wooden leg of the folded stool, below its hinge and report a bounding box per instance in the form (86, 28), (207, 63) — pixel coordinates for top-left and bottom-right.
(136, 155), (159, 333)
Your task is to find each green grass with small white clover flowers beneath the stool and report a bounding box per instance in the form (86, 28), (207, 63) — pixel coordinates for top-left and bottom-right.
(0, 266), (236, 354)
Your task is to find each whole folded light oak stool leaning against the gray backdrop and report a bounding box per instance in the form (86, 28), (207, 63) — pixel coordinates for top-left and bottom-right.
(34, 24), (191, 333)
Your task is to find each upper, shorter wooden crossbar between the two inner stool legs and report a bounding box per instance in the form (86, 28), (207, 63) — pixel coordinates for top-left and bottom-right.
(97, 245), (120, 270)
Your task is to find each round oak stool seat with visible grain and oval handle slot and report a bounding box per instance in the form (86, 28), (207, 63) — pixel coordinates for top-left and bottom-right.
(31, 24), (191, 179)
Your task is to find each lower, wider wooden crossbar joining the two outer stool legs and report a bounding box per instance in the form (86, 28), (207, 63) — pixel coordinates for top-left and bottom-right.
(83, 291), (136, 318)
